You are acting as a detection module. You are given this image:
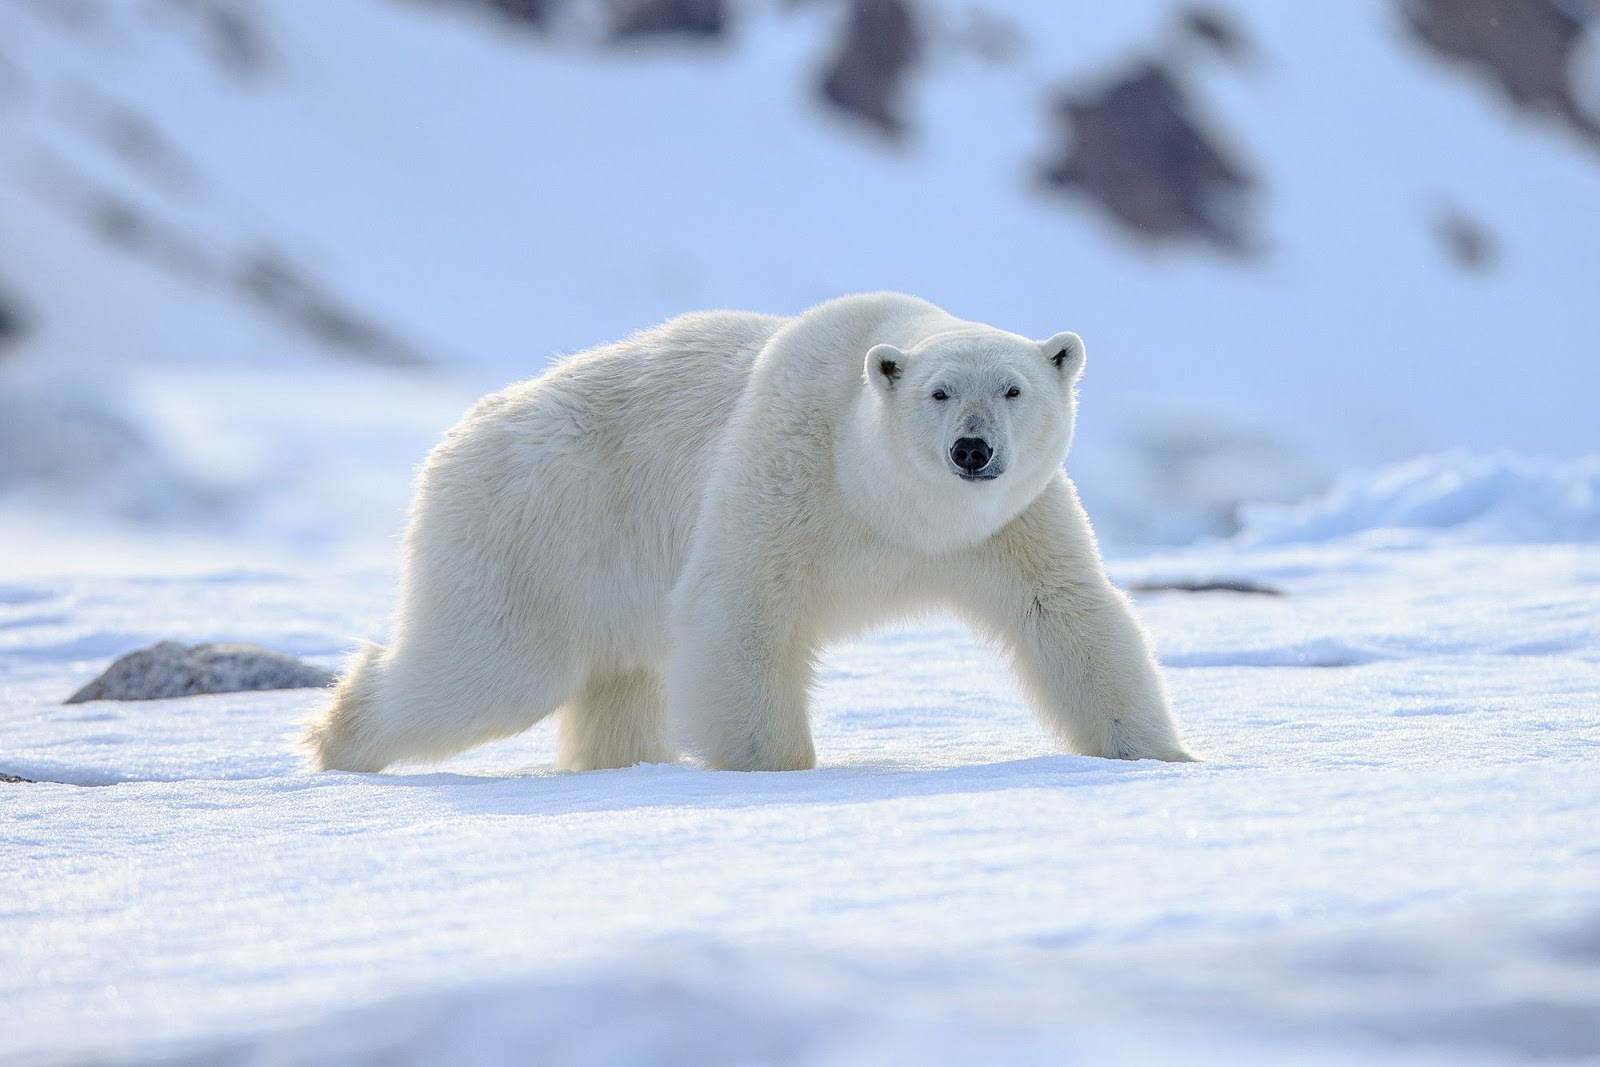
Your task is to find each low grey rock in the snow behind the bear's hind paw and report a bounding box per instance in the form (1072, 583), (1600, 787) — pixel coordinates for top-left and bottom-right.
(66, 641), (333, 704)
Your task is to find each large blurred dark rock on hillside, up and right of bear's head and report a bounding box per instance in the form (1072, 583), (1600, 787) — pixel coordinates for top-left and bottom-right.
(1040, 61), (1256, 253)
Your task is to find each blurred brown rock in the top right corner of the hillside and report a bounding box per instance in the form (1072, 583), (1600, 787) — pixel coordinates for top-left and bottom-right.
(1397, 0), (1600, 147)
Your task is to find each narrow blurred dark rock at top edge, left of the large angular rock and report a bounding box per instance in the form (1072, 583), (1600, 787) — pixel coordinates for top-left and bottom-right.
(821, 0), (925, 138)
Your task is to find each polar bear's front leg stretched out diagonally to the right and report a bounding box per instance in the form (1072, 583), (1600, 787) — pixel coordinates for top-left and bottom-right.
(952, 475), (1194, 760)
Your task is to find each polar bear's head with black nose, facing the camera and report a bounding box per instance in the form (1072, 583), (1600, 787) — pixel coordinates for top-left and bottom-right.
(864, 325), (1085, 536)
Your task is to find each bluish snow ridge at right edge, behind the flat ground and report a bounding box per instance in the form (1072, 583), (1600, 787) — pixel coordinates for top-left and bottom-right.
(1240, 453), (1600, 544)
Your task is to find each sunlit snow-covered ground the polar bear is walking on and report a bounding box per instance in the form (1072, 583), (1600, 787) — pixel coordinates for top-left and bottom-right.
(9, 470), (1600, 1064)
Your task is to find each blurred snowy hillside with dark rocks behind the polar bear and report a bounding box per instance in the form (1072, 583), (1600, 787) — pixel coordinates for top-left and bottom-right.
(0, 0), (1600, 565)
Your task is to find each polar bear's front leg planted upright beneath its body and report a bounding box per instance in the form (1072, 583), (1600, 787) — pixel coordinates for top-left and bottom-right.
(667, 558), (816, 771)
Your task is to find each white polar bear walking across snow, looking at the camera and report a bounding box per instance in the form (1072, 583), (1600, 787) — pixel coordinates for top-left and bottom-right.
(306, 293), (1192, 771)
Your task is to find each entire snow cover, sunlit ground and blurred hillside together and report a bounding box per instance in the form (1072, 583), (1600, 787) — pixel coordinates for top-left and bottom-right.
(0, 0), (1600, 1064)
